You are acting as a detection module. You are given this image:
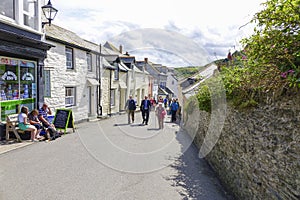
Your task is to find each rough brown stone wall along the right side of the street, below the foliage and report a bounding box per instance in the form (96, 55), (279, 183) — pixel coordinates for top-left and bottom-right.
(184, 93), (300, 199)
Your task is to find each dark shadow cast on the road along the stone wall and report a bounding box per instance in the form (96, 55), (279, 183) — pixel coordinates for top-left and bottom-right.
(167, 128), (234, 200)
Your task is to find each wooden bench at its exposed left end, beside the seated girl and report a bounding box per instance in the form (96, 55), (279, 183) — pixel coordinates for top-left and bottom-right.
(5, 114), (25, 142)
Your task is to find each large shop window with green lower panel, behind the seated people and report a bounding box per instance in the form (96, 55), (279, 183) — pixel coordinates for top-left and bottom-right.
(0, 57), (37, 120)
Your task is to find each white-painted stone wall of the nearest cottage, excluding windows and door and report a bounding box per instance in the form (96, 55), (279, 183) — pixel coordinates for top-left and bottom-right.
(44, 41), (97, 122)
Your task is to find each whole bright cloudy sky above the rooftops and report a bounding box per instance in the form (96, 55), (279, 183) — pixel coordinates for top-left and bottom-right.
(51, 0), (265, 66)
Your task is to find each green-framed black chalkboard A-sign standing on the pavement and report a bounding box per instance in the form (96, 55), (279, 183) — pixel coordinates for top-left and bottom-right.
(53, 108), (75, 133)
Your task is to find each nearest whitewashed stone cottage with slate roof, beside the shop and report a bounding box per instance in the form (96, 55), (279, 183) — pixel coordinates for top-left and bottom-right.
(43, 25), (102, 122)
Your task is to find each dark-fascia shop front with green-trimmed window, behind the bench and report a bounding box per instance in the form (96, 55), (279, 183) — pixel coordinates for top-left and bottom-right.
(0, 22), (53, 124)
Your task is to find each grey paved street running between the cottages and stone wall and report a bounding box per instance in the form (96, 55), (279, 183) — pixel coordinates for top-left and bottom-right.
(0, 112), (232, 200)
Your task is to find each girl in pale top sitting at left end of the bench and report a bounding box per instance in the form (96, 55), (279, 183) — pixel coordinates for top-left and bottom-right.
(18, 106), (38, 142)
